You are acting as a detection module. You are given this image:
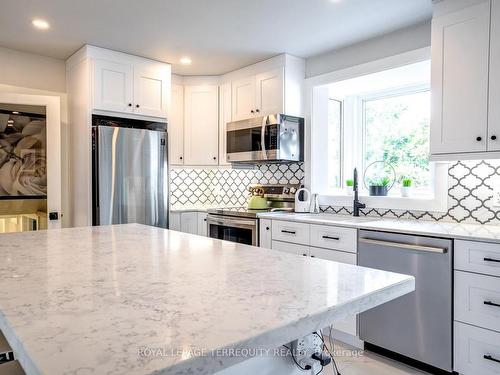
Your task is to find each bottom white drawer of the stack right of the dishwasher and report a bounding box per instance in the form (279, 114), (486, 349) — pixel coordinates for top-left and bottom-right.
(453, 322), (500, 375)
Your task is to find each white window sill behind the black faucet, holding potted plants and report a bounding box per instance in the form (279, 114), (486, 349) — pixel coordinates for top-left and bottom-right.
(319, 194), (448, 212)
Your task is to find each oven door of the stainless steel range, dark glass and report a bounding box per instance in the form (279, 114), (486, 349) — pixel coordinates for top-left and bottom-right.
(207, 215), (259, 246)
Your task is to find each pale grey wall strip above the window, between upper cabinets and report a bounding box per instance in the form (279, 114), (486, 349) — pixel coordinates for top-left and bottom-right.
(306, 21), (431, 77)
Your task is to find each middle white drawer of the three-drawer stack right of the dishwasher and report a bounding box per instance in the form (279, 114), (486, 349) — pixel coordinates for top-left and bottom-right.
(455, 271), (500, 332)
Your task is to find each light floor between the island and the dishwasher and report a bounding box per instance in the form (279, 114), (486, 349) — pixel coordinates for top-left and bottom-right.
(321, 343), (428, 375)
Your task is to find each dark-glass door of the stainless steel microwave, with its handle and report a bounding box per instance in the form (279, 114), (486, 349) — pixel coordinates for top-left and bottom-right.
(226, 117), (280, 163)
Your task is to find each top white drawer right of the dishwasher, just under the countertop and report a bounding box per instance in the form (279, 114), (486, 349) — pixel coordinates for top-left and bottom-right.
(455, 241), (500, 277)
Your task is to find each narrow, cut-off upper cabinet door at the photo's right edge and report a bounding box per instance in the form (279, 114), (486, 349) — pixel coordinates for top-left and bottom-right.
(488, 0), (500, 151)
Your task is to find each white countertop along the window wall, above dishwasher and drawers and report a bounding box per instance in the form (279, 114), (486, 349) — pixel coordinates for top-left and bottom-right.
(258, 212), (500, 243)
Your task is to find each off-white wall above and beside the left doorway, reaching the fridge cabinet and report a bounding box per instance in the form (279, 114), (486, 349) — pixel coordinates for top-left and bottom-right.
(0, 47), (70, 227)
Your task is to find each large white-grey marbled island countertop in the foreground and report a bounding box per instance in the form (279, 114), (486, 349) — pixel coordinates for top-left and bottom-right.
(0, 224), (415, 375)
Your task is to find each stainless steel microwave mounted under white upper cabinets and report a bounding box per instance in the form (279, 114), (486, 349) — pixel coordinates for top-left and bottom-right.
(226, 114), (304, 163)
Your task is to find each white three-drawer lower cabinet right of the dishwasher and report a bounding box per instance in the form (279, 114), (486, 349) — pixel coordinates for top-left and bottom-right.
(453, 241), (500, 375)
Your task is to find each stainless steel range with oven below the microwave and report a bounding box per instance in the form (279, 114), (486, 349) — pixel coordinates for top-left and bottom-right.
(207, 185), (300, 246)
